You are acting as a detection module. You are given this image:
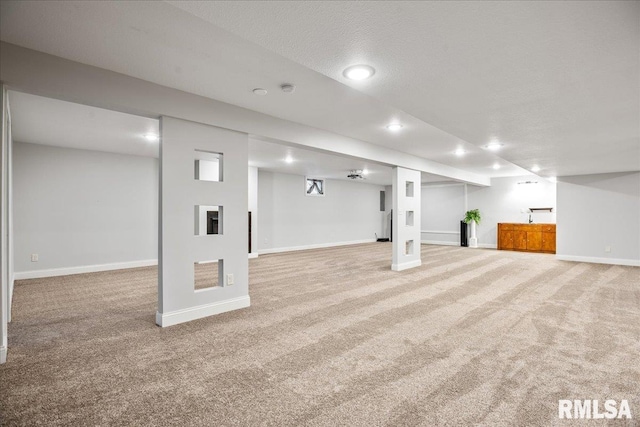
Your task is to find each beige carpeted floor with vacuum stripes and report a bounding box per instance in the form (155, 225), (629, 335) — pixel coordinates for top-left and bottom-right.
(0, 243), (640, 427)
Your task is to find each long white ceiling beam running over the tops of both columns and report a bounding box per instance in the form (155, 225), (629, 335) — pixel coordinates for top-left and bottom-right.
(0, 42), (490, 186)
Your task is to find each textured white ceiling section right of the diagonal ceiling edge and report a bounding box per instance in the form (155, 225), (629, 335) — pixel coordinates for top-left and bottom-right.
(171, 1), (640, 175)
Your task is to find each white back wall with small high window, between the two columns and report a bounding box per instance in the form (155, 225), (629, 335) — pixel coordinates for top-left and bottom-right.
(258, 171), (384, 253)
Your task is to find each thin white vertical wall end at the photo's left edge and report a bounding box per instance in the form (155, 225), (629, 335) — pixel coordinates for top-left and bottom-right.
(0, 85), (9, 363)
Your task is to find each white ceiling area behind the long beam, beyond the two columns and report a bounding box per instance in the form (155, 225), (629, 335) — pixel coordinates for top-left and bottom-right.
(9, 91), (424, 185)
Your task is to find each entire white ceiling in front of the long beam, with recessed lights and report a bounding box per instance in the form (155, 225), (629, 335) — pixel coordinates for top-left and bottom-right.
(0, 1), (640, 180)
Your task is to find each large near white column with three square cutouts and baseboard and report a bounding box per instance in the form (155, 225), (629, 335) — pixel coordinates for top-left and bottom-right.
(156, 117), (249, 326)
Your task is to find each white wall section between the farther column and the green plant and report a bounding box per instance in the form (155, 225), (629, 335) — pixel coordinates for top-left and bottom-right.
(422, 184), (466, 245)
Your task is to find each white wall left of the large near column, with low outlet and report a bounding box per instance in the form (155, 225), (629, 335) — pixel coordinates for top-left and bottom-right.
(13, 143), (158, 277)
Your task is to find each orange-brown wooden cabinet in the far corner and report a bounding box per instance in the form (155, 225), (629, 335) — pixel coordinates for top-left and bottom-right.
(498, 223), (556, 254)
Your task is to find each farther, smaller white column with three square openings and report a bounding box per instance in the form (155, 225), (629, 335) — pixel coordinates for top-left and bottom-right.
(391, 167), (422, 271)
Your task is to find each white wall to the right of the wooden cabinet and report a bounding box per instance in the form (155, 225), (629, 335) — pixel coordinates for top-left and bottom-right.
(556, 172), (640, 265)
